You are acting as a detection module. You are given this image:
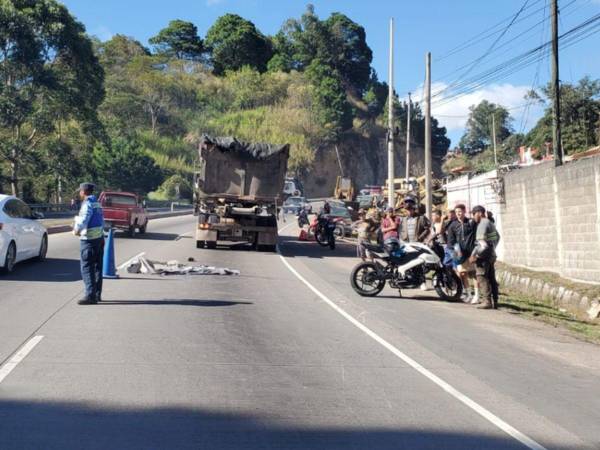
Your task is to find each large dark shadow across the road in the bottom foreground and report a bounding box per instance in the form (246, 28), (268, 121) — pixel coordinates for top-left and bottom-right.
(0, 400), (544, 450)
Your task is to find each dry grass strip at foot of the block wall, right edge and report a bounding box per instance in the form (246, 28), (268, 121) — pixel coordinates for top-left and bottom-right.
(499, 289), (600, 344)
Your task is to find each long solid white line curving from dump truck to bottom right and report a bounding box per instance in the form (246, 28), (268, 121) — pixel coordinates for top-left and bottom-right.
(279, 255), (546, 450)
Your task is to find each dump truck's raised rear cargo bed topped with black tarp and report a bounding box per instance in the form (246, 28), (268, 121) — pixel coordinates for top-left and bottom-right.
(197, 135), (290, 200)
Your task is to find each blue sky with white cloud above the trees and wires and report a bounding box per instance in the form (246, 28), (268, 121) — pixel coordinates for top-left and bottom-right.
(57, 0), (600, 146)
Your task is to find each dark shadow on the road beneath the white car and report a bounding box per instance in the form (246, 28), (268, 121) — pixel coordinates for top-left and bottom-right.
(0, 258), (81, 282)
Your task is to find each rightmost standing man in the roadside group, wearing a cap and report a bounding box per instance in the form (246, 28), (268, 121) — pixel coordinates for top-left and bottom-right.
(469, 206), (500, 309)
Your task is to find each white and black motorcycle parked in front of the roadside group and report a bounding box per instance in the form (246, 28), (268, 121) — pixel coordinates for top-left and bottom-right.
(350, 238), (463, 302)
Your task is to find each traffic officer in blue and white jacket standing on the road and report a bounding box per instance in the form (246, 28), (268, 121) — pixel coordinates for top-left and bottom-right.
(73, 183), (104, 305)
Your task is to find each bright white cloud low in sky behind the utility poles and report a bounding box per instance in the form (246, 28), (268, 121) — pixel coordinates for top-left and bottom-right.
(413, 81), (544, 134)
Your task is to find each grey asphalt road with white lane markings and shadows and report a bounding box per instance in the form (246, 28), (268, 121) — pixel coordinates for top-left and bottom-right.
(0, 216), (600, 450)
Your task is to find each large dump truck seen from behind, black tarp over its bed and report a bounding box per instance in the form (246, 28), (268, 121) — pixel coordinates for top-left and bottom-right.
(194, 135), (290, 251)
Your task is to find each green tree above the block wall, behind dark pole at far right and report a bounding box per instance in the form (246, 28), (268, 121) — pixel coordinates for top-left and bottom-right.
(525, 77), (600, 154)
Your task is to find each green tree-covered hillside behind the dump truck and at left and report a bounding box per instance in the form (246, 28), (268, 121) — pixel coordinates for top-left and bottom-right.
(0, 0), (450, 202)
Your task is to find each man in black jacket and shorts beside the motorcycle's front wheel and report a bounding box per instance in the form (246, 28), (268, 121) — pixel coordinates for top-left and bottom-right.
(447, 204), (479, 303)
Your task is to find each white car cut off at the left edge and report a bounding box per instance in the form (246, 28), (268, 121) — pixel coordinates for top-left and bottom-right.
(0, 194), (48, 272)
